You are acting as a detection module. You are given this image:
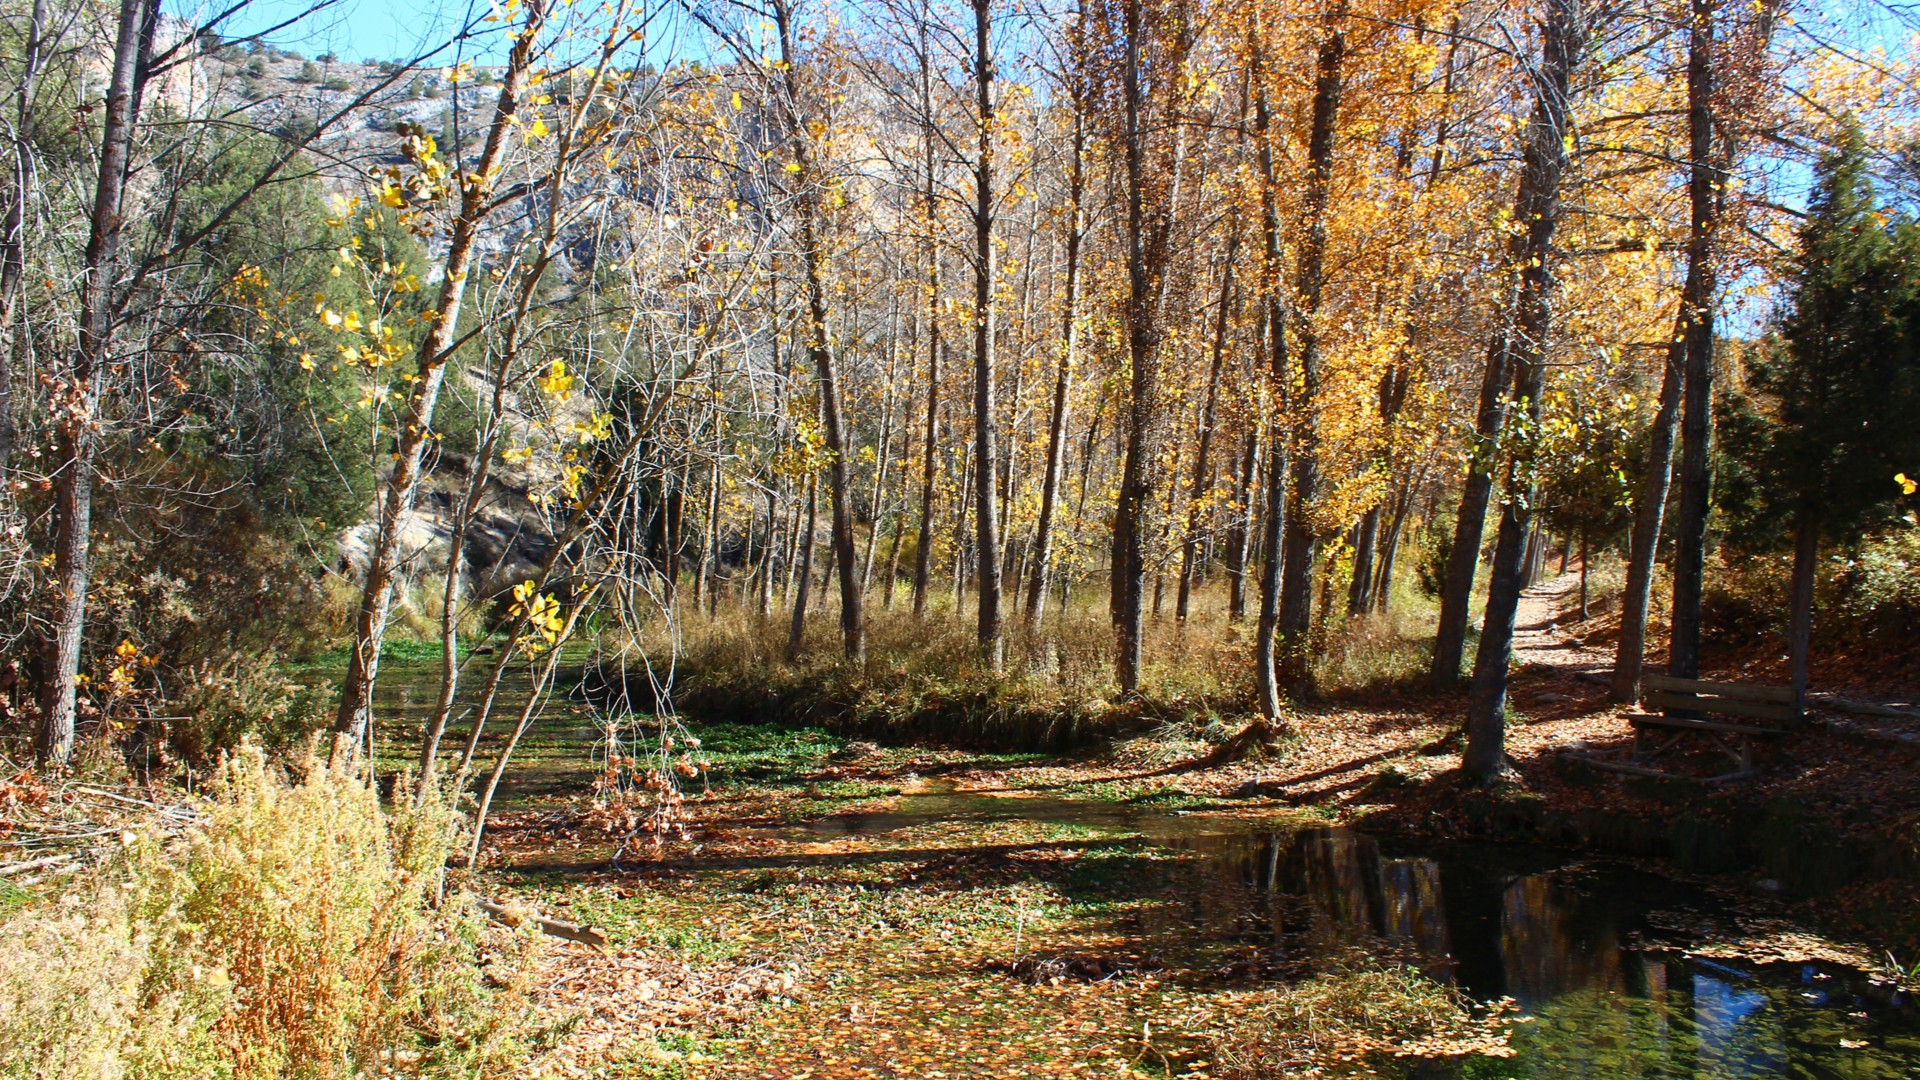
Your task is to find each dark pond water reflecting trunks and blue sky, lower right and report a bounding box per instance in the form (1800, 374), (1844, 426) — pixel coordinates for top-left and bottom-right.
(1164, 828), (1920, 1080)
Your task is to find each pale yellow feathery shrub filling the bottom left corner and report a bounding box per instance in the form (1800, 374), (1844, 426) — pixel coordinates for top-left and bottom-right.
(0, 748), (534, 1078)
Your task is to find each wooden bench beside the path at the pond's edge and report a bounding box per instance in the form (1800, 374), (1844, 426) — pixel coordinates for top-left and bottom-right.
(1626, 675), (1803, 782)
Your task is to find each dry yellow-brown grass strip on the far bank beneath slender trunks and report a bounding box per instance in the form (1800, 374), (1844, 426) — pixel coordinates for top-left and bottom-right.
(622, 588), (1430, 751)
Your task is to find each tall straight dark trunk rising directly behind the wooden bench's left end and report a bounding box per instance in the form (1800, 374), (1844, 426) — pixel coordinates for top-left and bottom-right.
(1667, 0), (1724, 678)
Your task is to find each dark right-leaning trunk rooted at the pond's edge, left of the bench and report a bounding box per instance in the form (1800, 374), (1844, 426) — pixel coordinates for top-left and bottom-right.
(1461, 0), (1586, 782)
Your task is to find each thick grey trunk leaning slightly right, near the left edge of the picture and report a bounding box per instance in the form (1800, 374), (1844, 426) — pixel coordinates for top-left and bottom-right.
(38, 0), (159, 765)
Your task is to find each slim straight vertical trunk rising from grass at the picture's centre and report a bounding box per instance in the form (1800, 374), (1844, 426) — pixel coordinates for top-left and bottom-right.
(973, 0), (1006, 675)
